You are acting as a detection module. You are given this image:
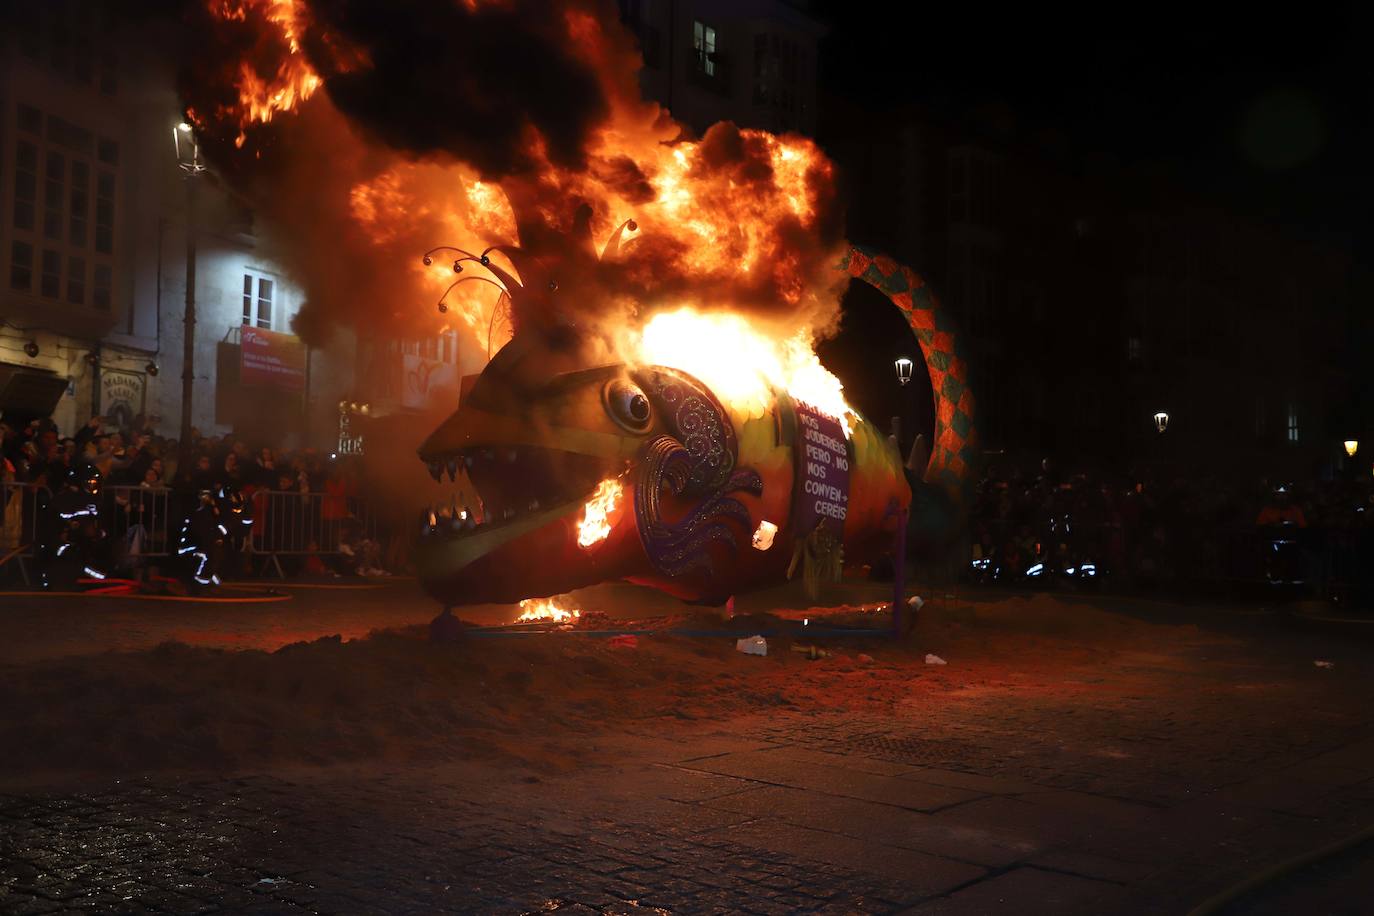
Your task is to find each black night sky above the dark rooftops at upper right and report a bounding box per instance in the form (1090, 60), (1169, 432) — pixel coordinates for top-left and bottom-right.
(816, 0), (1374, 251)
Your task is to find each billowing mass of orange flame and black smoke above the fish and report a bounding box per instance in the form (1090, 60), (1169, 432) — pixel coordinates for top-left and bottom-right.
(173, 0), (841, 350)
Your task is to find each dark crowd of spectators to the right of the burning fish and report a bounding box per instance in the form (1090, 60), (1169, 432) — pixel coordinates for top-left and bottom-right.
(970, 461), (1374, 601)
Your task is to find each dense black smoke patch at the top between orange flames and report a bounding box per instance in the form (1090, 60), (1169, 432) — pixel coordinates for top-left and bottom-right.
(305, 0), (623, 179)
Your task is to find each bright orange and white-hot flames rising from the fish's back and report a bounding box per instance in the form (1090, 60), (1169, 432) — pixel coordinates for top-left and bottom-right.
(190, 0), (852, 409)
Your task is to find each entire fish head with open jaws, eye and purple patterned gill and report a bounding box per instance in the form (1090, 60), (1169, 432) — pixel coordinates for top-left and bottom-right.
(416, 335), (761, 604)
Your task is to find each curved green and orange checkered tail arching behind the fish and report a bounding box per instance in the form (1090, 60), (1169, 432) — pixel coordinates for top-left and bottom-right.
(840, 246), (978, 508)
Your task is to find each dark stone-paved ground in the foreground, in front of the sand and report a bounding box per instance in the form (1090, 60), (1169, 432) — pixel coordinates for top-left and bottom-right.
(0, 596), (1374, 915)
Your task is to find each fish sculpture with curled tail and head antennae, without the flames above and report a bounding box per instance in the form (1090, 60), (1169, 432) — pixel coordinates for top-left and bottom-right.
(416, 224), (974, 604)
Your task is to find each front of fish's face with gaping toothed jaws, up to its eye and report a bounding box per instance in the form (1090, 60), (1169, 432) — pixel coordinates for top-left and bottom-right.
(406, 357), (655, 604)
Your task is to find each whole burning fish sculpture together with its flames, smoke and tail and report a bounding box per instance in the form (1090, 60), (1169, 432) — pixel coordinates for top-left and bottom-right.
(184, 0), (974, 610)
